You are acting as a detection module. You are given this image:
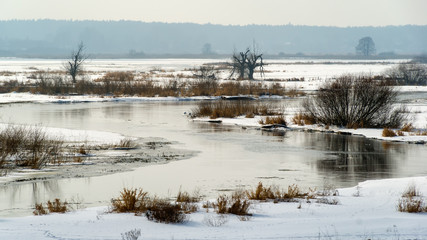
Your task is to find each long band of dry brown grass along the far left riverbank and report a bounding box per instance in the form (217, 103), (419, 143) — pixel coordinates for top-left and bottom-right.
(0, 69), (286, 97)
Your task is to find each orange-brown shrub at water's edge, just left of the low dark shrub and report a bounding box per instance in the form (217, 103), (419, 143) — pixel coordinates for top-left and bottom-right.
(111, 188), (149, 213)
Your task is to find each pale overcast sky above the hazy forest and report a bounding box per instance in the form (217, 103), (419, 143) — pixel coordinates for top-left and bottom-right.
(0, 0), (427, 27)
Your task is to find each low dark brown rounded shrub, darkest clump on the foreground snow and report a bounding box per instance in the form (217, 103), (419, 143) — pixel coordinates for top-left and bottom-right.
(145, 199), (186, 223)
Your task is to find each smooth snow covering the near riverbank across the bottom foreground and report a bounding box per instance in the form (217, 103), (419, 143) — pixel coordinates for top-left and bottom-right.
(0, 177), (427, 240)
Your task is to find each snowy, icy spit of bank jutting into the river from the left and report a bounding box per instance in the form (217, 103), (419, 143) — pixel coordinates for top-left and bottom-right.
(0, 124), (194, 186)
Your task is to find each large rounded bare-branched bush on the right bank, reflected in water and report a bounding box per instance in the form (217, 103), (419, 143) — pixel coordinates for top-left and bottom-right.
(303, 75), (406, 128)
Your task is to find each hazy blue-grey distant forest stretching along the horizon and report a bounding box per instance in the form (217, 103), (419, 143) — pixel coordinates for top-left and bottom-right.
(0, 20), (427, 58)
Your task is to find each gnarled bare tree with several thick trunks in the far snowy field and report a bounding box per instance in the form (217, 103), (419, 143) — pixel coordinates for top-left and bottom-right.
(230, 48), (264, 80)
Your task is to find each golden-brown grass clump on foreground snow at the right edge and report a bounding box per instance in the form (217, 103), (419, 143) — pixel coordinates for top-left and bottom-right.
(397, 185), (427, 213)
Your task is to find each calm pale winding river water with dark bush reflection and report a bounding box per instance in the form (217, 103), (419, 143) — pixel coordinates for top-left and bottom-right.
(0, 100), (427, 216)
